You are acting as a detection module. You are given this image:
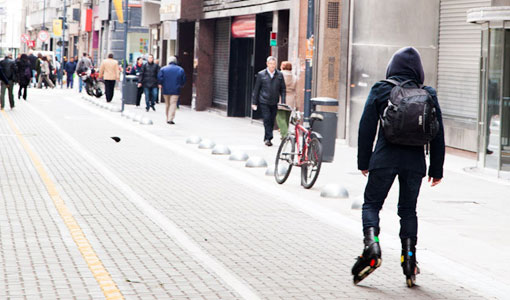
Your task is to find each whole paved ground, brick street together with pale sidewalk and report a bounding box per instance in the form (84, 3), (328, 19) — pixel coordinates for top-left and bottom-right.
(0, 85), (510, 299)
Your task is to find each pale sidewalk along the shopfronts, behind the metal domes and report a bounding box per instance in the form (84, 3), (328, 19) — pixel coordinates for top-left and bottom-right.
(104, 89), (510, 292)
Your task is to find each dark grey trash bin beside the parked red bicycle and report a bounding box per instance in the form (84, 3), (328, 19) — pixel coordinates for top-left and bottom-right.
(310, 97), (338, 162)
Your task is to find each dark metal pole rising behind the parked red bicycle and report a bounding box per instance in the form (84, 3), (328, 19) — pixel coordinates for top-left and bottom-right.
(304, 0), (315, 124)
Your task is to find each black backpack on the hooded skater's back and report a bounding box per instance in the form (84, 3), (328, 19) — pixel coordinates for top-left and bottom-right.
(381, 79), (439, 146)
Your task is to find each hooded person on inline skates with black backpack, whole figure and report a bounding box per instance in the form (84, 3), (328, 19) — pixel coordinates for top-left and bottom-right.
(352, 47), (445, 287)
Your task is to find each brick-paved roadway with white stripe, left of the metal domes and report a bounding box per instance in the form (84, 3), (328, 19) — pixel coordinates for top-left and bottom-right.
(0, 89), (502, 299)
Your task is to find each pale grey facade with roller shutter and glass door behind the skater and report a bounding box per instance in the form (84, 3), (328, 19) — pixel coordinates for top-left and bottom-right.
(338, 0), (510, 177)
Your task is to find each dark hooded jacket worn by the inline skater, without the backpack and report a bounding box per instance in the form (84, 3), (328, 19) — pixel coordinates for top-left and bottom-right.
(358, 47), (445, 179)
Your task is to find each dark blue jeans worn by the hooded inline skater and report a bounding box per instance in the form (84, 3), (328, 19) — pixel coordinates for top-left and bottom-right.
(362, 168), (423, 241)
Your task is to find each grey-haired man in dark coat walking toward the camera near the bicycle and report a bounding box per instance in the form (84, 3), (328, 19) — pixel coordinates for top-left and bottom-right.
(252, 56), (286, 147)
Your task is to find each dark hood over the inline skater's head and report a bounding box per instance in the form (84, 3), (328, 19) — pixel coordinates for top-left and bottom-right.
(386, 47), (425, 84)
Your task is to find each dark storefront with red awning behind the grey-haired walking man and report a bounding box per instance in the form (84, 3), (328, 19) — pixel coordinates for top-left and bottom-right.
(185, 0), (342, 118)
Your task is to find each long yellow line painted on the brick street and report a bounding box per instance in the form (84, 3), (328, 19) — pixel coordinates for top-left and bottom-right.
(2, 111), (124, 300)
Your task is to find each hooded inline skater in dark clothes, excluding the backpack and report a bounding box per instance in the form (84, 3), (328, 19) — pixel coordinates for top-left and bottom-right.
(352, 47), (445, 286)
